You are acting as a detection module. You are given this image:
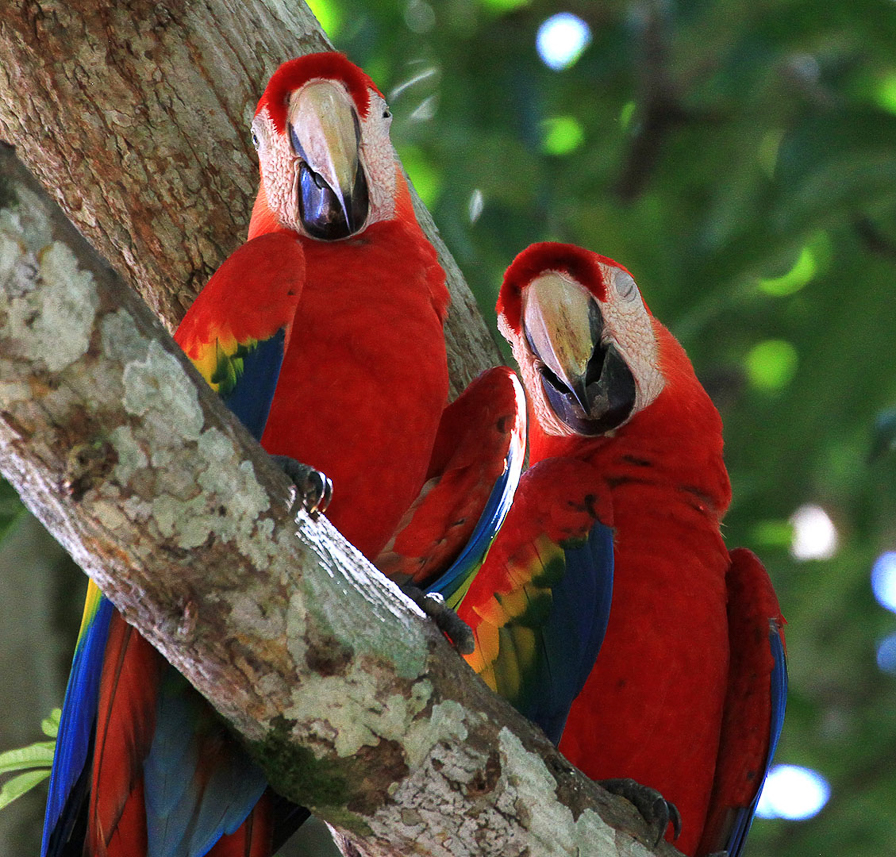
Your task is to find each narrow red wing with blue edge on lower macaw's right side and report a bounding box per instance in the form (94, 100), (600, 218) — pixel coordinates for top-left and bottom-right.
(698, 548), (787, 857)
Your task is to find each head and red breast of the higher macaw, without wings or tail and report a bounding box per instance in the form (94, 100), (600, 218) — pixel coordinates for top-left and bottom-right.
(249, 53), (448, 559)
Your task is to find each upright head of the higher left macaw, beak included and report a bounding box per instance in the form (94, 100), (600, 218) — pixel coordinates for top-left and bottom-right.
(250, 52), (397, 241)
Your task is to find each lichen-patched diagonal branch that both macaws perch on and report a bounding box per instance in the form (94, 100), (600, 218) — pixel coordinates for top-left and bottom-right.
(0, 142), (675, 855)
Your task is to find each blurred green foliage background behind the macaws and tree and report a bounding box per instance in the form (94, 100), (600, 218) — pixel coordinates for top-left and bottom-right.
(0, 0), (896, 857)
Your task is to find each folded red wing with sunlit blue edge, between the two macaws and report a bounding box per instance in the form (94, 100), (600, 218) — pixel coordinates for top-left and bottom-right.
(376, 366), (526, 592)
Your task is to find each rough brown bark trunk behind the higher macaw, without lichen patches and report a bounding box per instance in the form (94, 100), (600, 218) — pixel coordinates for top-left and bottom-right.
(0, 0), (500, 393)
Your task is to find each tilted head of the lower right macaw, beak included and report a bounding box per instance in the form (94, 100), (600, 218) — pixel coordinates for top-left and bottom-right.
(497, 242), (665, 437)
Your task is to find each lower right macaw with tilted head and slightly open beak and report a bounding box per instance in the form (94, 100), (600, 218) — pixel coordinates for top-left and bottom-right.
(476, 243), (786, 855)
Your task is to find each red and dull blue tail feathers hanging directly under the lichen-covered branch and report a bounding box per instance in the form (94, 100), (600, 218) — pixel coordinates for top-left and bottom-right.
(87, 613), (270, 857)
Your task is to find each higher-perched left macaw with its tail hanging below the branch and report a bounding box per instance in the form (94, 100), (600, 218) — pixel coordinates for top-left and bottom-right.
(42, 53), (448, 857)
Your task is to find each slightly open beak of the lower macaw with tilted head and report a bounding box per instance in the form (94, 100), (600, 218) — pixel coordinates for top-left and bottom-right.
(523, 272), (637, 436)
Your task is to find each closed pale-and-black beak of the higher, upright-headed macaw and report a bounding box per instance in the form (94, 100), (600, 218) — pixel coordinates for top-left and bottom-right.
(287, 80), (369, 241)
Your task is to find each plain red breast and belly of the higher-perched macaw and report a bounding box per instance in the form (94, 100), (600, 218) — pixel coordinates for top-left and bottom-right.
(261, 221), (448, 558)
